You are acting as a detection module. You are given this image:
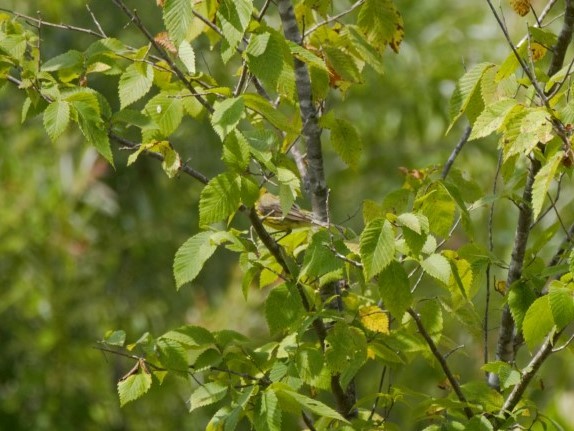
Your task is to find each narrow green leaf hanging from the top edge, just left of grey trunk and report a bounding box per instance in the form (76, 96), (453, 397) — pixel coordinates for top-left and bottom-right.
(217, 0), (253, 63)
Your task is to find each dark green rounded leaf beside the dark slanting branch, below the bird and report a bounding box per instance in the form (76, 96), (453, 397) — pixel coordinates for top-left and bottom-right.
(265, 284), (305, 334)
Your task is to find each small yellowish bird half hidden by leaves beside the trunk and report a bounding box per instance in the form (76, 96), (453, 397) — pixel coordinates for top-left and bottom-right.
(255, 191), (329, 230)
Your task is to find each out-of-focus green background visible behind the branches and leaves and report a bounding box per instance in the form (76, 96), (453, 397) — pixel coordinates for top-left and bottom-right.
(0, 0), (574, 431)
